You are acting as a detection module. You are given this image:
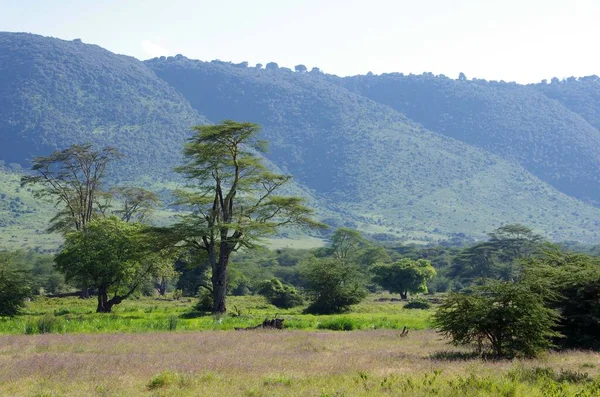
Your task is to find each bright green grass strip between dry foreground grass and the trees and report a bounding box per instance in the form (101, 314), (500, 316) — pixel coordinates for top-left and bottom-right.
(0, 296), (431, 334)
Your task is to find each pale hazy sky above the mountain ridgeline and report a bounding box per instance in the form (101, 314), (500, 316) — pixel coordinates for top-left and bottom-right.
(0, 0), (600, 83)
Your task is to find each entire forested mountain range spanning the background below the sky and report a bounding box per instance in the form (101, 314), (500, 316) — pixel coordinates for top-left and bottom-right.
(0, 33), (600, 247)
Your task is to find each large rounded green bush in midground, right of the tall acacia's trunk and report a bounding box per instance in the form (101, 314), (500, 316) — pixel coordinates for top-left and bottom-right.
(301, 258), (367, 314)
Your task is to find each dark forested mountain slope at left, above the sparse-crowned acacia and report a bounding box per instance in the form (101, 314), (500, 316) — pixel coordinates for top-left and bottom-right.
(0, 33), (208, 176)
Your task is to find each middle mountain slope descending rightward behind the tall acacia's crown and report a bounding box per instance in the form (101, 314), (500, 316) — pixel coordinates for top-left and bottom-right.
(146, 56), (600, 239)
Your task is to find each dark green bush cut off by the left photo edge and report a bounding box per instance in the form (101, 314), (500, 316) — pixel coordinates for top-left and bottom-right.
(0, 252), (31, 316)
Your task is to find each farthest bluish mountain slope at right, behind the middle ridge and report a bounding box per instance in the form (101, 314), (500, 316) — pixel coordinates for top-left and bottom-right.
(332, 73), (600, 202)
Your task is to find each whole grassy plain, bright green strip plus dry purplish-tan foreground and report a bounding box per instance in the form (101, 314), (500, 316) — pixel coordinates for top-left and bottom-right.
(0, 295), (600, 396)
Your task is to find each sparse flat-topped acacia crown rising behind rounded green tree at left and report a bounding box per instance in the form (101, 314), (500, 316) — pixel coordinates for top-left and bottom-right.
(21, 143), (122, 233)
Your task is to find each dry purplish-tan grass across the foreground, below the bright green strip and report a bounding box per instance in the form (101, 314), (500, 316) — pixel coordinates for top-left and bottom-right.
(0, 330), (600, 396)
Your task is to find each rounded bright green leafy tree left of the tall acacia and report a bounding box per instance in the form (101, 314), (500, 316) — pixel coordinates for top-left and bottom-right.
(54, 217), (170, 313)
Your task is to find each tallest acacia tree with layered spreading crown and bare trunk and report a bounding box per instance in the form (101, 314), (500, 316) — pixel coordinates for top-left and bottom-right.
(174, 120), (322, 313)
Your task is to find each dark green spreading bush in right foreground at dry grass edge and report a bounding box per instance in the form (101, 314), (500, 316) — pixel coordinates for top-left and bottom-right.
(434, 280), (558, 357)
